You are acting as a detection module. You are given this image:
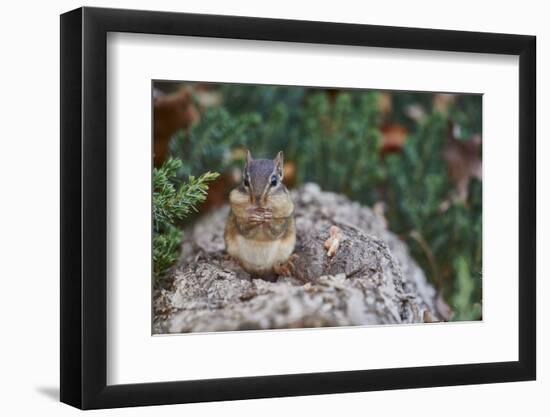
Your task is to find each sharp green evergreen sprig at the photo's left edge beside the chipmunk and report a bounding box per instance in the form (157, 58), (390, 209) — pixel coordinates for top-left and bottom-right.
(153, 159), (219, 280)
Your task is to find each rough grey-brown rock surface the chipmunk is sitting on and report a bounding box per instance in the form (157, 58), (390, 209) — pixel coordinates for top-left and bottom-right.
(153, 184), (441, 333)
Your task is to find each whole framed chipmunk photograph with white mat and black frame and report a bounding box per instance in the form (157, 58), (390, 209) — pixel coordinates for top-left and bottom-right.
(60, 7), (536, 409)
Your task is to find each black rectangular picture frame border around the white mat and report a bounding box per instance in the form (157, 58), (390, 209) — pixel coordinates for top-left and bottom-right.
(60, 7), (536, 409)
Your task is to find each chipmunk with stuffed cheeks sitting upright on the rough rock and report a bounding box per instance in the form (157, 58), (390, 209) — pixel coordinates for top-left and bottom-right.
(224, 151), (296, 277)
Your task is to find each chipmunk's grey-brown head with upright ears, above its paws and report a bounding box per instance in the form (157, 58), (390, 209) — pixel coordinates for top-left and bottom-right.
(241, 151), (286, 207)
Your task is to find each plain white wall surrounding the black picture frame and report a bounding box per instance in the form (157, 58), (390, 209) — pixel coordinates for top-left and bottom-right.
(0, 0), (550, 417)
